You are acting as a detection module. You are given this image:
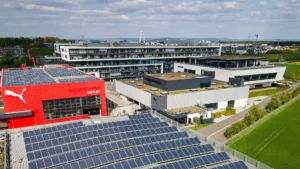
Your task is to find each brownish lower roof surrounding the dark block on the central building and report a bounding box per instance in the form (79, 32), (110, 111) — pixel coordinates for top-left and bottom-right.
(121, 80), (233, 96)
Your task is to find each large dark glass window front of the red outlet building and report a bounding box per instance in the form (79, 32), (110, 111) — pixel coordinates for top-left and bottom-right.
(43, 96), (101, 120)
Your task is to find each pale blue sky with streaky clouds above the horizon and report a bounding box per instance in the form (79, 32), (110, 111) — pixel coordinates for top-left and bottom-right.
(0, 0), (300, 39)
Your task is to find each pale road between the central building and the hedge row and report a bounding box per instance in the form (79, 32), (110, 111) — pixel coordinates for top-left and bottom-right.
(199, 86), (298, 143)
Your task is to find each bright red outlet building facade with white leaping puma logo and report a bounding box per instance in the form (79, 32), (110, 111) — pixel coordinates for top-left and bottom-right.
(1, 68), (107, 129)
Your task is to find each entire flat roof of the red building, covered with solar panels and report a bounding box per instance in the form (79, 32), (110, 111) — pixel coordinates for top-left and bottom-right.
(1, 67), (100, 87)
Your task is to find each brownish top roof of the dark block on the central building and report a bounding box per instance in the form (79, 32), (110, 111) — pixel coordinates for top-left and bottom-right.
(146, 72), (201, 80)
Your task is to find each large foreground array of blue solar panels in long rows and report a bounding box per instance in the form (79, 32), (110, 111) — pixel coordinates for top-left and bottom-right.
(19, 114), (248, 169)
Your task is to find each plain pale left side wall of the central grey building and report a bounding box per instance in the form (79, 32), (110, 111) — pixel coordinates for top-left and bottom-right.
(116, 81), (151, 107)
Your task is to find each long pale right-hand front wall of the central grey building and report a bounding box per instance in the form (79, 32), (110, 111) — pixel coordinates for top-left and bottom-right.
(167, 86), (249, 109)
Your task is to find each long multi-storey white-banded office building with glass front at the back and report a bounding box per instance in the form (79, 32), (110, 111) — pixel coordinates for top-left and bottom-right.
(54, 42), (221, 81)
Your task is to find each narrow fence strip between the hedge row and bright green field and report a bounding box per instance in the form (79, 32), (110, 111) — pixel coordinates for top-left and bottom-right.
(225, 95), (300, 144)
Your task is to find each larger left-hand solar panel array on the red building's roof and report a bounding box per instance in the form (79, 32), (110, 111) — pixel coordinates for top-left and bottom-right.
(3, 69), (56, 86)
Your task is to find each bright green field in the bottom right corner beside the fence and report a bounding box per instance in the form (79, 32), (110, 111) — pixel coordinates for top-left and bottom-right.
(229, 99), (300, 169)
